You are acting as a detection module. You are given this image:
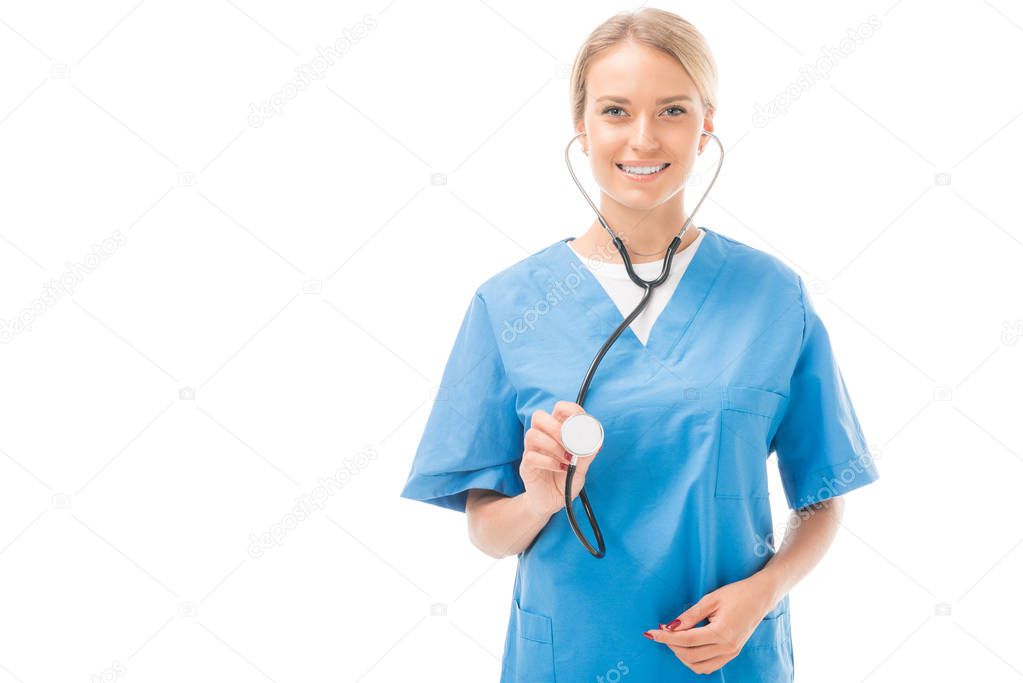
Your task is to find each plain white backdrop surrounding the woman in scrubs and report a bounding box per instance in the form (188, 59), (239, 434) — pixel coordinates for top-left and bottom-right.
(0, 0), (1023, 683)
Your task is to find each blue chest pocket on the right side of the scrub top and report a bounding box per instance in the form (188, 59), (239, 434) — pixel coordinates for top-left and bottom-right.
(714, 385), (788, 499)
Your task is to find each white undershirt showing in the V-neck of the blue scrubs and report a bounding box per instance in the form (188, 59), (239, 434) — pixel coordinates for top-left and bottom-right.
(567, 228), (705, 346)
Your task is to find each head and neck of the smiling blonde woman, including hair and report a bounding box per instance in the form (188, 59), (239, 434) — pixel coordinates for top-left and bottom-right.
(570, 9), (717, 263)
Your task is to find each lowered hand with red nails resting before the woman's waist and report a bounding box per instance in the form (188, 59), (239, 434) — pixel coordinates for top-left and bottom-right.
(644, 575), (774, 674)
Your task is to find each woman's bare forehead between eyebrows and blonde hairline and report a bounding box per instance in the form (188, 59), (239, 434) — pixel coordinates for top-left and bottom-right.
(586, 42), (698, 100)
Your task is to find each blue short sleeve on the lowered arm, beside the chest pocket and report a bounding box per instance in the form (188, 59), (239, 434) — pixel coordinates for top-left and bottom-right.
(771, 278), (879, 509)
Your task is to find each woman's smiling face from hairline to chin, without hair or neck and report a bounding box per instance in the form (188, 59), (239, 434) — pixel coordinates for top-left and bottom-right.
(576, 42), (714, 210)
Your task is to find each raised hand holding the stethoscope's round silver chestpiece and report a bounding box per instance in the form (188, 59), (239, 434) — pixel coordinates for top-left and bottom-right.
(519, 401), (599, 516)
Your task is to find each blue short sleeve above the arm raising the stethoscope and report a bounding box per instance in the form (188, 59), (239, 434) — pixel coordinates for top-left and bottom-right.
(401, 292), (525, 512)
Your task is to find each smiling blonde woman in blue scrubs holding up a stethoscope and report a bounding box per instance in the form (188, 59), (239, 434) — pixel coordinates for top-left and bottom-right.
(401, 8), (878, 683)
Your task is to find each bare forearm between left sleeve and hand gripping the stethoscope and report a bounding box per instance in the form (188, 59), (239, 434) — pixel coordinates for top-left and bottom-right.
(465, 489), (557, 558)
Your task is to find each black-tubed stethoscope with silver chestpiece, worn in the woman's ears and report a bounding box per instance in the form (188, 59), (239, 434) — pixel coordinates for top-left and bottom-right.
(561, 131), (724, 559)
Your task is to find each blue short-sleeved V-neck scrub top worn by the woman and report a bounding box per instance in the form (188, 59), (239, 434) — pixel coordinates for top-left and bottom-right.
(401, 228), (878, 683)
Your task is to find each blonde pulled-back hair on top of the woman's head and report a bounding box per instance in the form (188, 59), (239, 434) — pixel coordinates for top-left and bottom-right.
(570, 7), (717, 126)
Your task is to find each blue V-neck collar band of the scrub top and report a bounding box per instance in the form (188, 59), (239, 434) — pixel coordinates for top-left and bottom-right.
(550, 227), (726, 363)
